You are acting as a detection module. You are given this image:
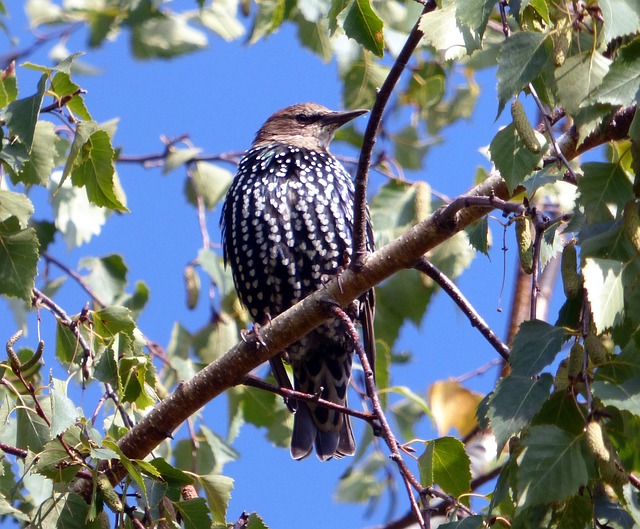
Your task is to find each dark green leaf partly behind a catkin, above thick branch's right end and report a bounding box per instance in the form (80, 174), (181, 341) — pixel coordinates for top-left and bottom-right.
(489, 123), (546, 193)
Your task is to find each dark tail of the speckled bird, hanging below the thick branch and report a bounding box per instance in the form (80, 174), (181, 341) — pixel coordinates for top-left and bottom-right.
(290, 333), (356, 461)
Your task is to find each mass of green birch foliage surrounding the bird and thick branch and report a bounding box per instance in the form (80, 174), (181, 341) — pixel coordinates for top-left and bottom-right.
(0, 0), (640, 528)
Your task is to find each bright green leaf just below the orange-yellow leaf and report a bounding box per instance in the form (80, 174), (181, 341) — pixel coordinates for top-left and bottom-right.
(418, 437), (471, 498)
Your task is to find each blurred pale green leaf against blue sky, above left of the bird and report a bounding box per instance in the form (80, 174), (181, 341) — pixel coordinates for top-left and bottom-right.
(131, 14), (208, 59)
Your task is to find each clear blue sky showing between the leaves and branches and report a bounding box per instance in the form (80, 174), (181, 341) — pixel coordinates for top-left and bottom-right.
(0, 2), (557, 528)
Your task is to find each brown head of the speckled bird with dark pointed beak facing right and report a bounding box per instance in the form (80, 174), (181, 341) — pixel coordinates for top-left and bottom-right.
(253, 103), (368, 152)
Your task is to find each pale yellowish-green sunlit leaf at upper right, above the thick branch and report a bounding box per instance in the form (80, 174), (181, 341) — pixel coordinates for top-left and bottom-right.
(554, 51), (611, 115)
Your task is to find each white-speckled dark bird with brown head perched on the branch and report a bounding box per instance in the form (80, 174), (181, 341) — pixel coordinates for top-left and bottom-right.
(220, 103), (375, 461)
